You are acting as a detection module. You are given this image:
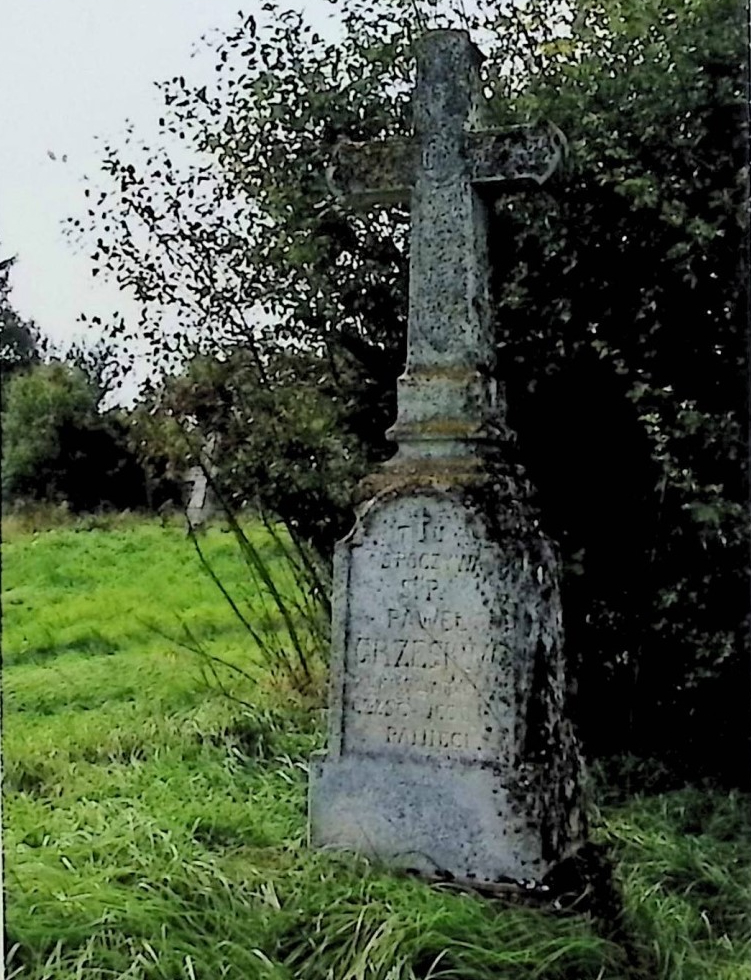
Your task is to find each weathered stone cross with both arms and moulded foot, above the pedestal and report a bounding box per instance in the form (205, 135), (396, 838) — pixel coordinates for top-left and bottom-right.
(328, 31), (564, 456)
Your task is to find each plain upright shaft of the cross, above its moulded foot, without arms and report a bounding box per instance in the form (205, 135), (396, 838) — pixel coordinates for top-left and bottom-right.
(407, 31), (492, 371)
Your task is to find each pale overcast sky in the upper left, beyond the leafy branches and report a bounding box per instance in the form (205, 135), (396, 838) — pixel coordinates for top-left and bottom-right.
(0, 0), (338, 386)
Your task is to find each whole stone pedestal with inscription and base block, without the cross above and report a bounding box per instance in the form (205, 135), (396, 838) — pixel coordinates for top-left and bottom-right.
(310, 464), (581, 882)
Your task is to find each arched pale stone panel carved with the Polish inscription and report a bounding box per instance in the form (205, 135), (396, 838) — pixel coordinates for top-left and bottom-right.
(343, 497), (514, 761)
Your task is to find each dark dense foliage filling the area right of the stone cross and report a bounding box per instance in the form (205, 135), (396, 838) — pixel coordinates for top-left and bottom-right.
(482, 0), (749, 778)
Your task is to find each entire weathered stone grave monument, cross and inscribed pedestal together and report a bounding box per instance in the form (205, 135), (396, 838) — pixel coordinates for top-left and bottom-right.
(309, 31), (584, 884)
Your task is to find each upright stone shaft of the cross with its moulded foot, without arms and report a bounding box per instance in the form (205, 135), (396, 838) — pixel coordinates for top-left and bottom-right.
(392, 31), (496, 458)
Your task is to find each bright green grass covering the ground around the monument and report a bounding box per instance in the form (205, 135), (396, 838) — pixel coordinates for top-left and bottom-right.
(3, 517), (751, 980)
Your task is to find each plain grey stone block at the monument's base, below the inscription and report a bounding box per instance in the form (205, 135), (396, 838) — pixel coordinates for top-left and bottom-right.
(310, 756), (550, 884)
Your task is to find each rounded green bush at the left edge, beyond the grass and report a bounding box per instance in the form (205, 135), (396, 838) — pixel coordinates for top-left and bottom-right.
(2, 361), (148, 510)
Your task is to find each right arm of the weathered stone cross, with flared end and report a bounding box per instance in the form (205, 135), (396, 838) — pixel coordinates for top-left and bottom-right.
(467, 123), (566, 185)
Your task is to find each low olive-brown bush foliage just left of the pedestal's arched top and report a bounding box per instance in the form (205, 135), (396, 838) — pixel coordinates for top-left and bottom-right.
(131, 346), (377, 554)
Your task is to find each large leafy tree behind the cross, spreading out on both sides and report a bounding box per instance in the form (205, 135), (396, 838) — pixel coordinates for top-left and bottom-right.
(78, 0), (749, 771)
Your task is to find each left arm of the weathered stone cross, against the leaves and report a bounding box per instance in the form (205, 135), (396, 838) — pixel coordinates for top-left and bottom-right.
(326, 138), (419, 207)
